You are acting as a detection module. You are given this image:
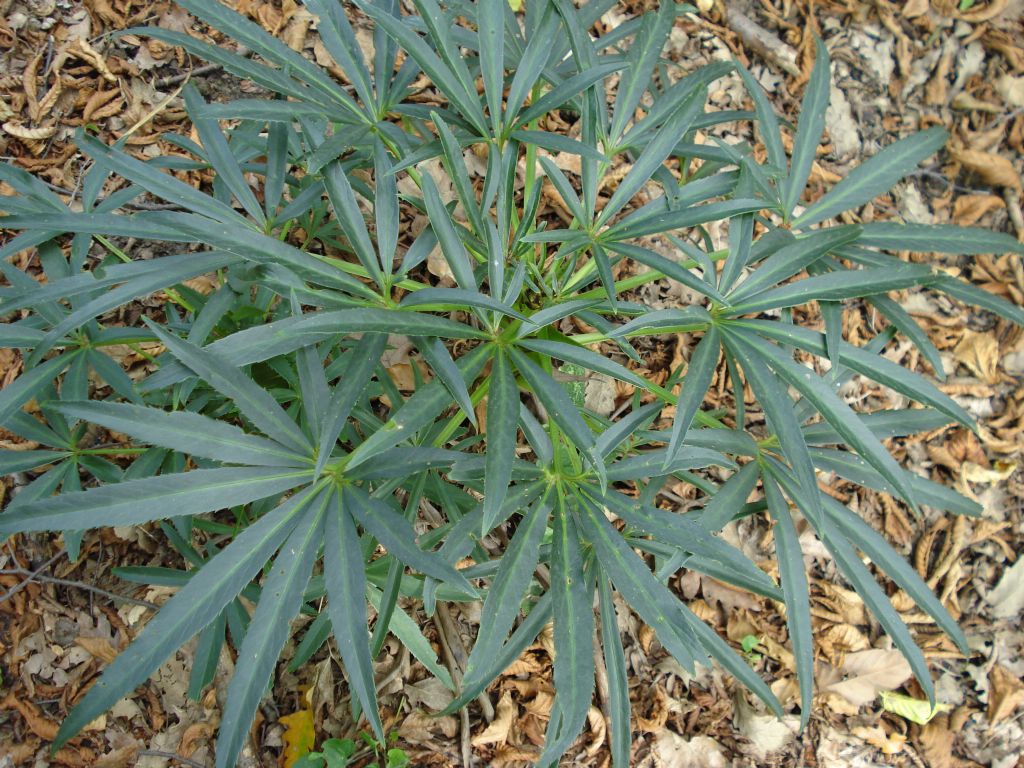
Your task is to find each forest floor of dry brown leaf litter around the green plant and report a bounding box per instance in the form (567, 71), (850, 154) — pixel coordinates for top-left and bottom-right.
(0, 0), (1024, 768)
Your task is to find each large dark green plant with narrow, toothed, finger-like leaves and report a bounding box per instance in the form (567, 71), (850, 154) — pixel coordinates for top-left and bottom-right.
(0, 0), (1024, 766)
